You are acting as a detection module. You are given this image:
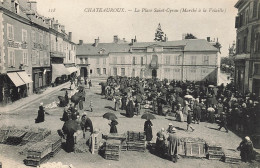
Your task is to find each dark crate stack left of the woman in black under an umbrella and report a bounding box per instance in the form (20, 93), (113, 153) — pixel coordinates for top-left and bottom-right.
(126, 131), (146, 152)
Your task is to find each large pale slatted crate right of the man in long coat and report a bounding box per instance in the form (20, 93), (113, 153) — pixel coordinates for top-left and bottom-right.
(184, 142), (206, 158)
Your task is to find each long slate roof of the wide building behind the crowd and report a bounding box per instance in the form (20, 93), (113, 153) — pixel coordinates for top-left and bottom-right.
(76, 39), (218, 56)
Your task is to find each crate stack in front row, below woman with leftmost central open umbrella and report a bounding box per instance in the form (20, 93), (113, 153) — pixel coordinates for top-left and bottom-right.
(105, 140), (121, 161)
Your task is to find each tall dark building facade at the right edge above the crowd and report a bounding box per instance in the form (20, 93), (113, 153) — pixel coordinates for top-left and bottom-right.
(235, 0), (260, 96)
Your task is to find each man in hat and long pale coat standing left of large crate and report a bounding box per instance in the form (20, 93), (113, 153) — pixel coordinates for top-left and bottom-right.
(168, 127), (180, 163)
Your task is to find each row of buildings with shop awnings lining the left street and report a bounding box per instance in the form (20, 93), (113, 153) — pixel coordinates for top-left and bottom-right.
(0, 0), (77, 105)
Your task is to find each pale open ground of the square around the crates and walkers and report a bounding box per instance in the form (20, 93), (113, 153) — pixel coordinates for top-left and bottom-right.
(0, 79), (260, 168)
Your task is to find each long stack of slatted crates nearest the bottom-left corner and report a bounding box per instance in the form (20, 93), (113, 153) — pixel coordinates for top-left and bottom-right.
(24, 141), (52, 167)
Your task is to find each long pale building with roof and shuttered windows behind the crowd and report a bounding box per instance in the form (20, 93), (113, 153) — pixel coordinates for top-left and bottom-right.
(77, 36), (218, 84)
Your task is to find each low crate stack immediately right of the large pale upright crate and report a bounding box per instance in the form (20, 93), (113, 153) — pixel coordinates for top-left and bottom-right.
(207, 145), (224, 160)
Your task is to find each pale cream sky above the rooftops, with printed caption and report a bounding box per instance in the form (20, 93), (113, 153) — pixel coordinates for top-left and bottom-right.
(36, 0), (237, 56)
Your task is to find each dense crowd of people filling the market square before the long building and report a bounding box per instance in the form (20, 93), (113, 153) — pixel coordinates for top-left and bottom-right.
(100, 76), (260, 134)
